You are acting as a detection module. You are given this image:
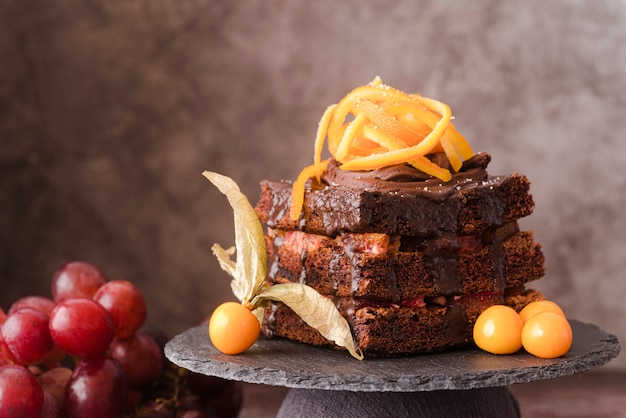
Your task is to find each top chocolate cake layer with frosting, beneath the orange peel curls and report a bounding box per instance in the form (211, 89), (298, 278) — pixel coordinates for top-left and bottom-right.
(255, 155), (534, 237)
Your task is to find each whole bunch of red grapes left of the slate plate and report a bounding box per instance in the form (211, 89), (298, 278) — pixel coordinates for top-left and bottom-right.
(0, 261), (243, 418)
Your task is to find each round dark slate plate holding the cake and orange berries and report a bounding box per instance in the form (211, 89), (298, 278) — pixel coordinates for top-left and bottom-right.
(165, 320), (620, 392)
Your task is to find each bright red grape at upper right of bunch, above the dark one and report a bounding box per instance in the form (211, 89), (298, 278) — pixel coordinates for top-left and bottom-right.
(93, 280), (148, 338)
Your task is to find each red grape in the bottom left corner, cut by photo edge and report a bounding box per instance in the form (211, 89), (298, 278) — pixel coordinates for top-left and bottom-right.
(0, 364), (43, 418)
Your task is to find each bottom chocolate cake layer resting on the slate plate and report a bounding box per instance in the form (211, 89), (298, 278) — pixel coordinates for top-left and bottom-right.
(263, 291), (544, 357)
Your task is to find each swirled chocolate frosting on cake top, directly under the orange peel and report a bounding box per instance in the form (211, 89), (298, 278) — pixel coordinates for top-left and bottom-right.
(322, 152), (491, 198)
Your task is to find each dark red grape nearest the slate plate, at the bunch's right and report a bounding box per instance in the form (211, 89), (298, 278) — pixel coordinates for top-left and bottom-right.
(109, 331), (164, 389)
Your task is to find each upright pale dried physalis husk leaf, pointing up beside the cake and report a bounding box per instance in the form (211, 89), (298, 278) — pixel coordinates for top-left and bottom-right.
(202, 171), (267, 305)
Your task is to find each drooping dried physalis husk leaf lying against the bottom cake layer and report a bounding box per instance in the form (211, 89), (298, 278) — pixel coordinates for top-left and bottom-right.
(252, 283), (363, 360)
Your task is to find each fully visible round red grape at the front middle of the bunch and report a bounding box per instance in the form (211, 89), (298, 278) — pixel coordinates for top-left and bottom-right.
(50, 298), (115, 358)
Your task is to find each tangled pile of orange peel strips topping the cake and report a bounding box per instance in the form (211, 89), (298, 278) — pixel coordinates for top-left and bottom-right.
(290, 77), (474, 221)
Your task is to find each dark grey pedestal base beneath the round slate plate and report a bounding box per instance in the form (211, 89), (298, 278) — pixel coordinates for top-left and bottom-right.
(277, 387), (521, 418)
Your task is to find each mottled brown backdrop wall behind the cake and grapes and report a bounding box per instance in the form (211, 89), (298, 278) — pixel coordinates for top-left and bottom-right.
(0, 0), (626, 368)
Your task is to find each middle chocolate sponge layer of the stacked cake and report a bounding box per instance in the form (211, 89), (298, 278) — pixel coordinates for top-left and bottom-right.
(266, 223), (545, 302)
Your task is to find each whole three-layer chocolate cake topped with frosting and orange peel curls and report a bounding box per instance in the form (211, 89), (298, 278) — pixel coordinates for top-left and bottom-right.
(255, 78), (545, 357)
